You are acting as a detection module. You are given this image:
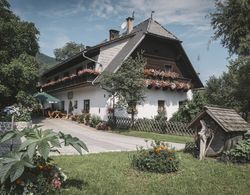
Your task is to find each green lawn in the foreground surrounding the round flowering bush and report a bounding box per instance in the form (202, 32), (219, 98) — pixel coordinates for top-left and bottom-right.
(54, 152), (250, 195)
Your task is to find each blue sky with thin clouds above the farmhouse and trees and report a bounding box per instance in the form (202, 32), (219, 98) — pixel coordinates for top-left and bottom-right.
(9, 0), (229, 84)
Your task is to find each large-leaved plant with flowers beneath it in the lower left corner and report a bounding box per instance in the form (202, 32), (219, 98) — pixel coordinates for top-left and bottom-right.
(0, 127), (88, 194)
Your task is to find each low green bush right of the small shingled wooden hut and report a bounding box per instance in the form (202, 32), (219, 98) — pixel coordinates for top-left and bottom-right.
(221, 139), (250, 163)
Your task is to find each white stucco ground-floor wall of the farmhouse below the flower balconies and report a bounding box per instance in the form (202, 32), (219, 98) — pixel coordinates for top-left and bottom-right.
(49, 86), (192, 120)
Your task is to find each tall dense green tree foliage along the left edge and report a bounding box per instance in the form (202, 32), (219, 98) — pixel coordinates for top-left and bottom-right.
(0, 0), (39, 108)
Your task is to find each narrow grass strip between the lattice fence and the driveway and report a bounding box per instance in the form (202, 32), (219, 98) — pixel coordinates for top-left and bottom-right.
(112, 130), (194, 143)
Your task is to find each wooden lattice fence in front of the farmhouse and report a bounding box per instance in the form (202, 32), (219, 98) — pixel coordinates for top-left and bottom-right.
(108, 117), (194, 136)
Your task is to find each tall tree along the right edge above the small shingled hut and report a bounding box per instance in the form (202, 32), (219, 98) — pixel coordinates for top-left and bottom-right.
(206, 0), (250, 118)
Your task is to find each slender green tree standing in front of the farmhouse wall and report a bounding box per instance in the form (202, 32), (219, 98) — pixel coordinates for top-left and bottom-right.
(101, 52), (145, 124)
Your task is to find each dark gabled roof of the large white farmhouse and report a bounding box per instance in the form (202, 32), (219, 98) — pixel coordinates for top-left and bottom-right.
(43, 18), (203, 88)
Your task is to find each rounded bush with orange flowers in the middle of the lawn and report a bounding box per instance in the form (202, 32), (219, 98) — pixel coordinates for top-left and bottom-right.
(132, 141), (179, 173)
